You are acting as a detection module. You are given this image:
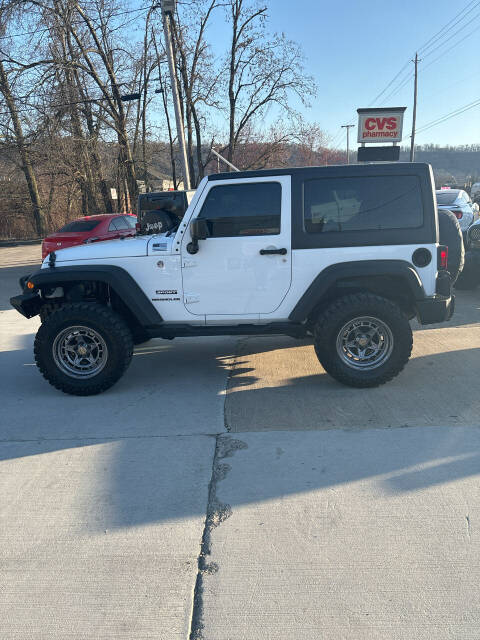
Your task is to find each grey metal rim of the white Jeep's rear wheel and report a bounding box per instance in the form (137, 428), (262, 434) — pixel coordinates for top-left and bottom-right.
(337, 316), (393, 371)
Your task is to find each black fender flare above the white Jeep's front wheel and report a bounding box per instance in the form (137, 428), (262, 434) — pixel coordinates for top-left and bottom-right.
(25, 265), (162, 327)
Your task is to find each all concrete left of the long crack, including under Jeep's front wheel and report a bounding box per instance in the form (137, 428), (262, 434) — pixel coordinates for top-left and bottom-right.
(0, 247), (235, 640)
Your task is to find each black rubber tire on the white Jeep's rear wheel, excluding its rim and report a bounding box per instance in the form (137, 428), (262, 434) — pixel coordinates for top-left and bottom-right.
(314, 293), (413, 387)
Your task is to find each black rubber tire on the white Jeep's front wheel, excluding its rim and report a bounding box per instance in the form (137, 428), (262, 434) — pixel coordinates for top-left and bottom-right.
(34, 302), (133, 396)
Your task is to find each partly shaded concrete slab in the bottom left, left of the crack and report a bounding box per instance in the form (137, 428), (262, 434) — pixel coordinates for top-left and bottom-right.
(0, 436), (215, 640)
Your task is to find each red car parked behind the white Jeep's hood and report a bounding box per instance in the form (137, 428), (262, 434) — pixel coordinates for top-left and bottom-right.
(42, 213), (137, 260)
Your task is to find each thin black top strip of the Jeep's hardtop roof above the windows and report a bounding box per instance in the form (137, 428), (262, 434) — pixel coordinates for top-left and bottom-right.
(207, 162), (430, 181)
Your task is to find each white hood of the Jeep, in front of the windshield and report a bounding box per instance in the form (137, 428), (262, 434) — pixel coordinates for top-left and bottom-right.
(43, 236), (150, 266)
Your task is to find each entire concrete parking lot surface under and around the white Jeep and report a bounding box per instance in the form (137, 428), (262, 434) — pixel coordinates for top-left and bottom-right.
(0, 246), (480, 640)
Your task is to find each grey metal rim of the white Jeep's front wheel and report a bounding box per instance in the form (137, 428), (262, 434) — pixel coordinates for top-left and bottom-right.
(52, 326), (108, 380)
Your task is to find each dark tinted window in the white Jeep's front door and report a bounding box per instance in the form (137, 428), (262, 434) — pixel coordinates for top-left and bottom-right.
(199, 182), (282, 238)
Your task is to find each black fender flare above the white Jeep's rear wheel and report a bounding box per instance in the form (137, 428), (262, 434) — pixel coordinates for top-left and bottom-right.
(289, 260), (426, 322)
